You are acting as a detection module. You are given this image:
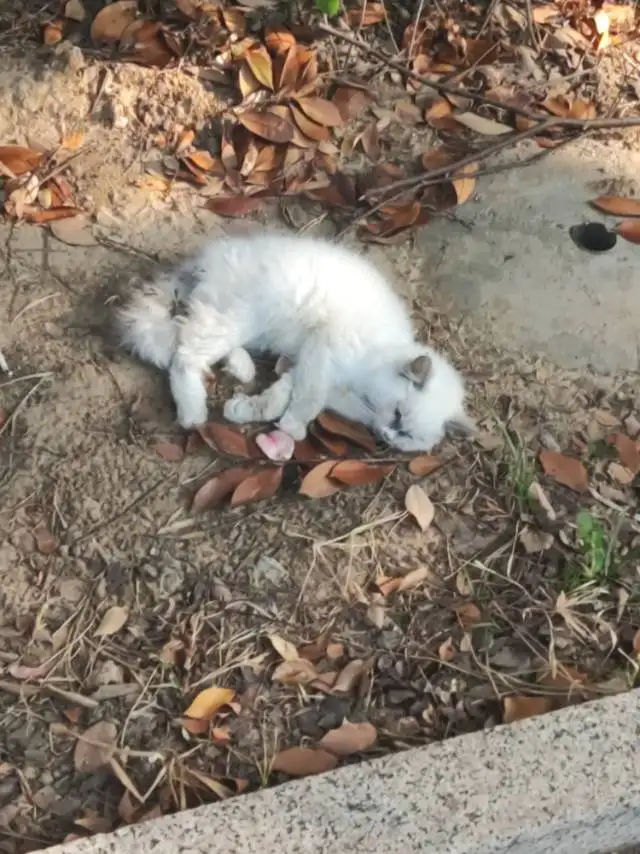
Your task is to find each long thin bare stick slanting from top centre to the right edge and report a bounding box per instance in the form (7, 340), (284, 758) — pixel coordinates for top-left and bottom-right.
(318, 24), (640, 130)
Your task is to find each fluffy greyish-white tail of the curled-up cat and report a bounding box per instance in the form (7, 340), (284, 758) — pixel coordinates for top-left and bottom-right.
(116, 275), (184, 368)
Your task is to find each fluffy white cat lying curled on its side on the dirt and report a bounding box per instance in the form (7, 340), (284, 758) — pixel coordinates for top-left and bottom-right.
(119, 233), (472, 451)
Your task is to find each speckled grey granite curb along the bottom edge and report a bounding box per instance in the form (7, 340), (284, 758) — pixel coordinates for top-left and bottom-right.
(42, 691), (640, 854)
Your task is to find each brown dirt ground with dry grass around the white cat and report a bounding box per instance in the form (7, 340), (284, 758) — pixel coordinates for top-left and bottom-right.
(0, 6), (640, 854)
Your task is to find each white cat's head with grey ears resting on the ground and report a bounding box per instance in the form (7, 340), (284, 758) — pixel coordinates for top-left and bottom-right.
(366, 347), (476, 451)
